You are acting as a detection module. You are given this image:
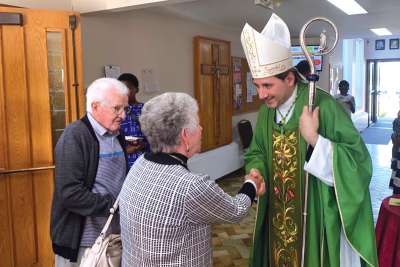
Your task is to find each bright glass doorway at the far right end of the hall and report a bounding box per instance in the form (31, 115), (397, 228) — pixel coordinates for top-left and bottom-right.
(366, 59), (400, 123)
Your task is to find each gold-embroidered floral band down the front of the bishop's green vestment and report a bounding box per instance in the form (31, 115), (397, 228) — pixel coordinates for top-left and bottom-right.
(266, 126), (304, 267)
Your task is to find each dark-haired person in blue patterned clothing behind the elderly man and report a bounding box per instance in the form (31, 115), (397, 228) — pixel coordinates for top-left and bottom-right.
(118, 73), (149, 168)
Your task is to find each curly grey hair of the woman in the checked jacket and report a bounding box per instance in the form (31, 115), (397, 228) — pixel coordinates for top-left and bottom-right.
(139, 93), (199, 153)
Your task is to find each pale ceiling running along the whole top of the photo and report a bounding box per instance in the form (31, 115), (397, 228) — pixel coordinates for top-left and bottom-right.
(6, 0), (400, 39)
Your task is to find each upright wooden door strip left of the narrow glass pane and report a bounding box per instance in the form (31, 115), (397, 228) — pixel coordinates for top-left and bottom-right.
(25, 24), (54, 266)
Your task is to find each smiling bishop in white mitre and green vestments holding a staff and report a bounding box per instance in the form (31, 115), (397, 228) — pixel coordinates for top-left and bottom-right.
(241, 14), (377, 267)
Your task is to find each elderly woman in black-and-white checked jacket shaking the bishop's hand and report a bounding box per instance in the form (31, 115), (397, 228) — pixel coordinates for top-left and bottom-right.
(120, 93), (265, 267)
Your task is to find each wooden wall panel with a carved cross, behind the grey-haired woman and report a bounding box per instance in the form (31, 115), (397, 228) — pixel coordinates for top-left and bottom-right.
(194, 36), (233, 151)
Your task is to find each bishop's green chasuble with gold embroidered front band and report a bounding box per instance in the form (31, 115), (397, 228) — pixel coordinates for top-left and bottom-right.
(245, 83), (378, 267)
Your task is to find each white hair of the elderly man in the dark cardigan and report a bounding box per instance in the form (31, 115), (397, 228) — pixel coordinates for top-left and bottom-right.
(86, 78), (129, 113)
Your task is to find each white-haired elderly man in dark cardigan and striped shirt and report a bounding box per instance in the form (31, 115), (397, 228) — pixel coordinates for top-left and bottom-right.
(50, 78), (128, 267)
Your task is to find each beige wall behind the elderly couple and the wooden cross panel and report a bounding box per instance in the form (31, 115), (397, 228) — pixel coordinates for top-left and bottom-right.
(82, 10), (256, 146)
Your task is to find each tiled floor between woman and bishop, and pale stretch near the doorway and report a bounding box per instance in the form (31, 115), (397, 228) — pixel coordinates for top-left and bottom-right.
(213, 143), (392, 267)
